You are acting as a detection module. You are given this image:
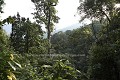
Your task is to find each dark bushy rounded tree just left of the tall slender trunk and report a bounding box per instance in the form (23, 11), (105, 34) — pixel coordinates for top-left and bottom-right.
(10, 14), (43, 53)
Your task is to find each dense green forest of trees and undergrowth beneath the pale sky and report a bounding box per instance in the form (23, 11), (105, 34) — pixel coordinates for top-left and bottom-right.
(0, 0), (120, 80)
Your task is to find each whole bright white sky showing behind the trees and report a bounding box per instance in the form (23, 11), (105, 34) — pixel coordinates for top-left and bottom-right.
(1, 0), (89, 32)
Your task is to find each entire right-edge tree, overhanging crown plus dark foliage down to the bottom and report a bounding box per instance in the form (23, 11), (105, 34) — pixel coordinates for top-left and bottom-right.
(78, 0), (120, 80)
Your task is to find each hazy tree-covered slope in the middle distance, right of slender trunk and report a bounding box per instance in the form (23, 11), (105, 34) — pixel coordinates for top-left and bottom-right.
(51, 21), (102, 72)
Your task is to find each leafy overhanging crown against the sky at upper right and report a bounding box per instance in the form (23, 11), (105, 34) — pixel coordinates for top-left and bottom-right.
(78, 0), (119, 22)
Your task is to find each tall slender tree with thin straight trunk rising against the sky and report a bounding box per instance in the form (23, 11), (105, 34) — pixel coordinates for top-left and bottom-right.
(31, 0), (59, 53)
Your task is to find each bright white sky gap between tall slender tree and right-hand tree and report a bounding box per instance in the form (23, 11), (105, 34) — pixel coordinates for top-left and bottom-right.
(56, 0), (79, 29)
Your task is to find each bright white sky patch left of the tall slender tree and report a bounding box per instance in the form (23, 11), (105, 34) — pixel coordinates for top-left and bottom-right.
(2, 0), (34, 19)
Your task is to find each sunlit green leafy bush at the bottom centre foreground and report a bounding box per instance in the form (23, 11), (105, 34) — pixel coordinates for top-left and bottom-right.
(40, 60), (81, 80)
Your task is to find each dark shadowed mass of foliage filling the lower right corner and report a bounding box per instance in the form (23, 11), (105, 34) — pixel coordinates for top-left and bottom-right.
(89, 15), (120, 80)
